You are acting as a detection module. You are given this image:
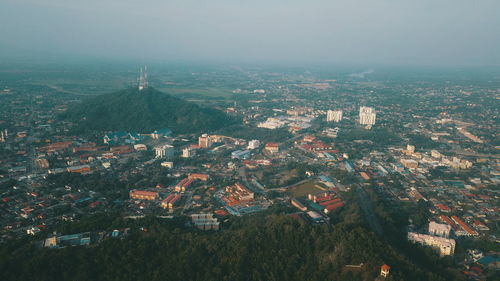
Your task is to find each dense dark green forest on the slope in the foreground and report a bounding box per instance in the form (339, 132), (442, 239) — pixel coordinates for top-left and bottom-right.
(0, 200), (458, 281)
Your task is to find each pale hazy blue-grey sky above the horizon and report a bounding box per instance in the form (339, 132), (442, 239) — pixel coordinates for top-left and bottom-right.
(0, 0), (500, 65)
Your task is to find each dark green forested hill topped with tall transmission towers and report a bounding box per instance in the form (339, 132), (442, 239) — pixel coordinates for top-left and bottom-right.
(60, 88), (233, 133)
